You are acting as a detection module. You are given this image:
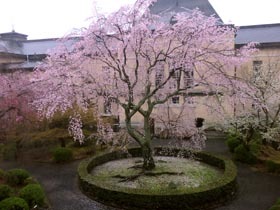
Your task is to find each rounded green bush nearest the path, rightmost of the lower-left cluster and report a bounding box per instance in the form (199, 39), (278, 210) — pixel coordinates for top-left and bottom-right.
(19, 184), (45, 208)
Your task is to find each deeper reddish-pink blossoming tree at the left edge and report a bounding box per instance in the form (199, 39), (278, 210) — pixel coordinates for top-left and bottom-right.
(0, 71), (36, 139)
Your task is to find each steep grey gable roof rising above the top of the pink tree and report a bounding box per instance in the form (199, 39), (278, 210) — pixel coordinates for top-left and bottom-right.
(150, 0), (222, 22)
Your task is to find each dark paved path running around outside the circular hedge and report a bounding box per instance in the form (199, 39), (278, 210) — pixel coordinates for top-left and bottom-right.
(0, 133), (280, 210)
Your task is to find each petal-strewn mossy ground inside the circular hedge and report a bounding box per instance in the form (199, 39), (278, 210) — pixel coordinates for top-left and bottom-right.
(91, 156), (222, 193)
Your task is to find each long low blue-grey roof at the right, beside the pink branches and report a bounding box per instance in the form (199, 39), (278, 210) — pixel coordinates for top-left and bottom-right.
(235, 23), (280, 45)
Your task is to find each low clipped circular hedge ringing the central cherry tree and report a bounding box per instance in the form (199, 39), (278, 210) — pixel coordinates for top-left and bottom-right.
(78, 147), (237, 210)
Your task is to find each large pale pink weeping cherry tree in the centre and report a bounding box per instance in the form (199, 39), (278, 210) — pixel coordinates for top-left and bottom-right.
(31, 0), (255, 169)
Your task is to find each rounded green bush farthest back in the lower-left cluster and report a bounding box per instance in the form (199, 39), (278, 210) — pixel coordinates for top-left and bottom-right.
(5, 169), (30, 186)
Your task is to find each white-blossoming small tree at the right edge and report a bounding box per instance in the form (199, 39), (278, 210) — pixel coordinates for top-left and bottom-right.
(227, 57), (280, 145)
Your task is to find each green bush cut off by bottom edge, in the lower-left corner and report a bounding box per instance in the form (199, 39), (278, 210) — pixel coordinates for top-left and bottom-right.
(0, 197), (29, 210)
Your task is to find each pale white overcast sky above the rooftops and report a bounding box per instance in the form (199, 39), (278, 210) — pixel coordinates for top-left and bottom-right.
(0, 0), (280, 39)
